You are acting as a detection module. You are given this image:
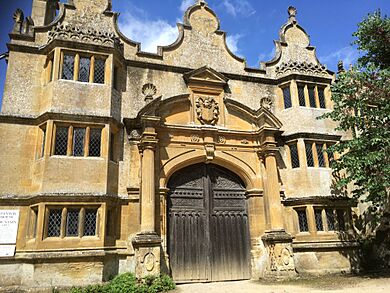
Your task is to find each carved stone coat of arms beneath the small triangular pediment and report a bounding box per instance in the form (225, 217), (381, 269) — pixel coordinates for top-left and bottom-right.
(195, 97), (219, 125)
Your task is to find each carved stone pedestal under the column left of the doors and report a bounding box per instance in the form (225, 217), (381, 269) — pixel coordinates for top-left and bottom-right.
(132, 233), (161, 277)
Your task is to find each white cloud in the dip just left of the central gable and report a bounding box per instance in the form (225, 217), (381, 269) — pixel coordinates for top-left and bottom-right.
(119, 7), (178, 53)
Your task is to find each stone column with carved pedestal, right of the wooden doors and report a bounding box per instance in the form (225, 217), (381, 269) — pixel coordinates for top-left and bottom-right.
(262, 134), (296, 279)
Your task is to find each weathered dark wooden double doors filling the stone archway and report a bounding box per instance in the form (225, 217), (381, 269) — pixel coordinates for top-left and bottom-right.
(168, 164), (250, 282)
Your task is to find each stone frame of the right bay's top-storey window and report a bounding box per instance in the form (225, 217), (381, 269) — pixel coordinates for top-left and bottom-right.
(296, 81), (330, 110)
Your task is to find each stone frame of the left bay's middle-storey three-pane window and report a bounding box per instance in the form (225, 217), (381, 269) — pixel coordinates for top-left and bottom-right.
(51, 122), (105, 158)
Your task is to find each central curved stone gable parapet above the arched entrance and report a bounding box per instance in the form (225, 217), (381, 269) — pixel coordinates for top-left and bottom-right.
(111, 1), (247, 74)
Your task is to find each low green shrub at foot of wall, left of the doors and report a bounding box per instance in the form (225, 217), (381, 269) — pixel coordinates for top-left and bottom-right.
(62, 273), (176, 293)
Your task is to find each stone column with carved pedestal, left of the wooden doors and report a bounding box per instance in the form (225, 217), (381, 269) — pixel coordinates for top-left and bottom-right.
(133, 116), (161, 277)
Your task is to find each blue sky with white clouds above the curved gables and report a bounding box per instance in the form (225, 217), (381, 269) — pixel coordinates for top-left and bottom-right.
(0, 0), (390, 109)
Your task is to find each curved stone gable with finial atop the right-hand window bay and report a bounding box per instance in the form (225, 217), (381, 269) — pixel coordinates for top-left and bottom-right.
(262, 7), (333, 78)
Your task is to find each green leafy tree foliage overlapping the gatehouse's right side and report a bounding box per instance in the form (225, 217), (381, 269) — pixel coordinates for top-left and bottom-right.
(322, 11), (390, 226)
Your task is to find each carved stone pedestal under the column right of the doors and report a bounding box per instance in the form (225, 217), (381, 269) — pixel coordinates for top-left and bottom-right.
(262, 230), (297, 280)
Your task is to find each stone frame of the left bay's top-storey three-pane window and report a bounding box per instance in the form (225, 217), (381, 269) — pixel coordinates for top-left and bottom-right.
(59, 50), (109, 85)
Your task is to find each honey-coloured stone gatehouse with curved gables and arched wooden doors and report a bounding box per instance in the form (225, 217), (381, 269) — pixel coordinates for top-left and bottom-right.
(0, 0), (357, 286)
